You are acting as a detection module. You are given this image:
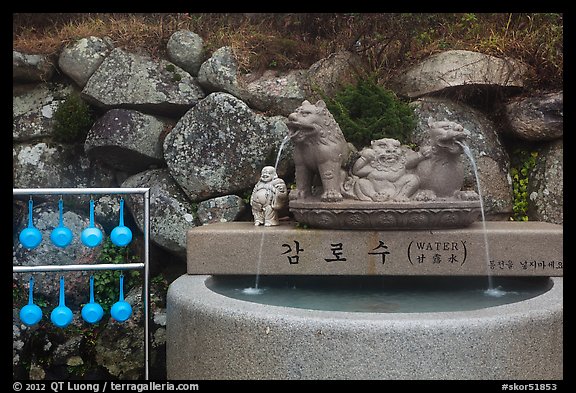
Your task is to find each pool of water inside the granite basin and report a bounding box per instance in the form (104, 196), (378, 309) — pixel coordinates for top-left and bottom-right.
(207, 276), (552, 313)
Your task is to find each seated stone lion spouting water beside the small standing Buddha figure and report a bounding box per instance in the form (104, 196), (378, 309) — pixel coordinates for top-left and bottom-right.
(286, 100), (350, 202)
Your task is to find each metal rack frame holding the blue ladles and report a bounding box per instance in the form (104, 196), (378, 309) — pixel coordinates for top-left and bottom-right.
(12, 188), (150, 380)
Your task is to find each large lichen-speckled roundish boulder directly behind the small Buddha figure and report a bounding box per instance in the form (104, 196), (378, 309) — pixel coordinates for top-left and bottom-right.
(164, 93), (288, 201)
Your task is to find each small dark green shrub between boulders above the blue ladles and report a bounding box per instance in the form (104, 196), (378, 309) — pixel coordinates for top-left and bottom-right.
(53, 93), (94, 143)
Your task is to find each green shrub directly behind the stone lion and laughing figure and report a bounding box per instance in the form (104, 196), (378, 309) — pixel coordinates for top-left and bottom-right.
(325, 78), (416, 149)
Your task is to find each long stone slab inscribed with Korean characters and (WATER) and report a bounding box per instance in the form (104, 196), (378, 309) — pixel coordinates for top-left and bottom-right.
(187, 221), (564, 277)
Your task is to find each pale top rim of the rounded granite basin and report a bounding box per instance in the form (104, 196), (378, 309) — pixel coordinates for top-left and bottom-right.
(171, 274), (564, 325)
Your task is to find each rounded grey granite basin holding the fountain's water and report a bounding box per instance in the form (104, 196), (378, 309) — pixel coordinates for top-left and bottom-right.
(167, 274), (563, 380)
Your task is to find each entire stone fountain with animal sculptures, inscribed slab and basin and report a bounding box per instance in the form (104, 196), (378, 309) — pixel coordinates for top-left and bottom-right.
(167, 101), (563, 380)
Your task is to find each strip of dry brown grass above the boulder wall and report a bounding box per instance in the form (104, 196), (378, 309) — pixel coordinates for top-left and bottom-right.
(13, 13), (563, 89)
